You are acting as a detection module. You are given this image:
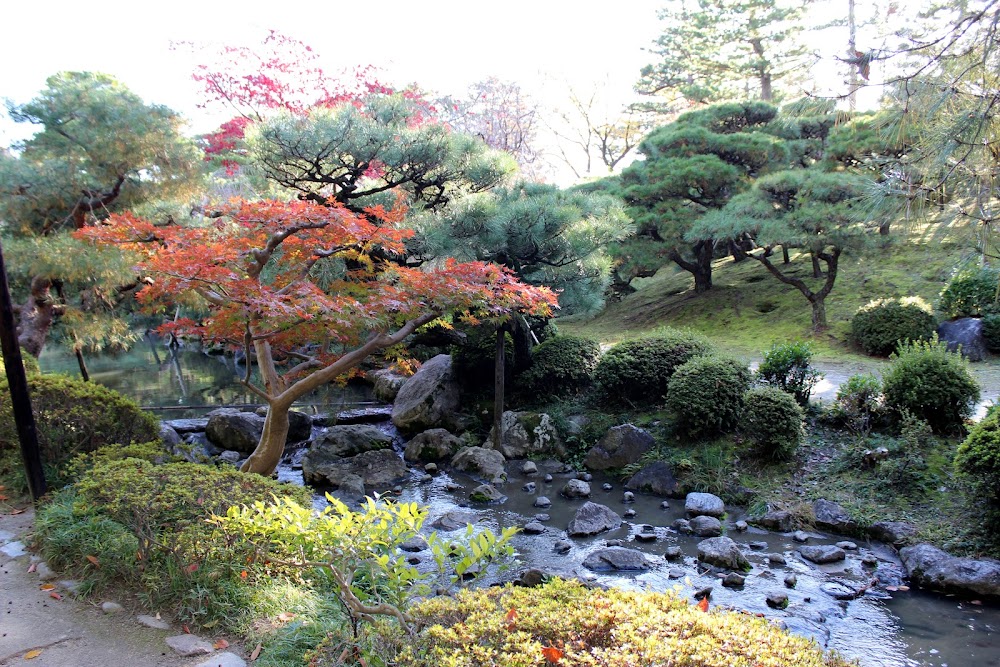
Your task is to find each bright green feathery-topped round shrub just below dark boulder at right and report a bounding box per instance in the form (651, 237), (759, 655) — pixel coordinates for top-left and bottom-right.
(882, 336), (979, 433)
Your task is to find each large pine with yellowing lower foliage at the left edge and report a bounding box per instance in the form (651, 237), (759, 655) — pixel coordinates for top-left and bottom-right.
(0, 72), (201, 355)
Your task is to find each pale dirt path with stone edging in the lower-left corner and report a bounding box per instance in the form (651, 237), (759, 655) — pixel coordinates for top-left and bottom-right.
(0, 503), (246, 667)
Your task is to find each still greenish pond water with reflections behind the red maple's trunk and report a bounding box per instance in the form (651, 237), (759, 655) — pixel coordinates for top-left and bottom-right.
(39, 337), (373, 419)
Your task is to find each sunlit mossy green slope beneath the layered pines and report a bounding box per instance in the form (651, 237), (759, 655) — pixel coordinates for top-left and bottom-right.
(559, 224), (972, 361)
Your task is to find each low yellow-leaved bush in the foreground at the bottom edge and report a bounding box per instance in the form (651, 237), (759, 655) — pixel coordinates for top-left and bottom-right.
(386, 579), (850, 667)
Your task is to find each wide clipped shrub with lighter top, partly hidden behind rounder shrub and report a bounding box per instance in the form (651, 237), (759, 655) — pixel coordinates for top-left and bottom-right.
(594, 329), (713, 406)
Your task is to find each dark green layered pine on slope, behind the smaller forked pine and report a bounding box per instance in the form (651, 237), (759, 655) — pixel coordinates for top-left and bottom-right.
(616, 102), (789, 292)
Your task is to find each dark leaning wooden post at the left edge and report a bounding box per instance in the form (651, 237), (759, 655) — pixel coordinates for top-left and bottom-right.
(0, 244), (47, 500)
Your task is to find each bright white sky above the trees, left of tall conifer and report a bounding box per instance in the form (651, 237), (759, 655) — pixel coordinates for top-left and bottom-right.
(0, 0), (662, 146)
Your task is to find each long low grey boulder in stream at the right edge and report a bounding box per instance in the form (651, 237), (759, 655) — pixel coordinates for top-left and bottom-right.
(899, 544), (1000, 596)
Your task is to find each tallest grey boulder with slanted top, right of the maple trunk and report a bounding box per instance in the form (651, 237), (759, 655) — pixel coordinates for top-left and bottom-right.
(392, 354), (459, 433)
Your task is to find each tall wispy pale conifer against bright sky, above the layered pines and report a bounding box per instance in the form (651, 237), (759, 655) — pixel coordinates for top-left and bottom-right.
(637, 0), (808, 107)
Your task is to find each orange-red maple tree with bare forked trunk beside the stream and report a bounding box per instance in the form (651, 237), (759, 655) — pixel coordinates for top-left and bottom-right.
(76, 200), (556, 475)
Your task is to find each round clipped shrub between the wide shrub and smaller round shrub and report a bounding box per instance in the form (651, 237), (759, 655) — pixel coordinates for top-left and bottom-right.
(667, 356), (752, 438)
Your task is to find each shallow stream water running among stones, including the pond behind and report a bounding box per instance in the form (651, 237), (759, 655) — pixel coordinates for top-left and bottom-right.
(40, 344), (1000, 667)
